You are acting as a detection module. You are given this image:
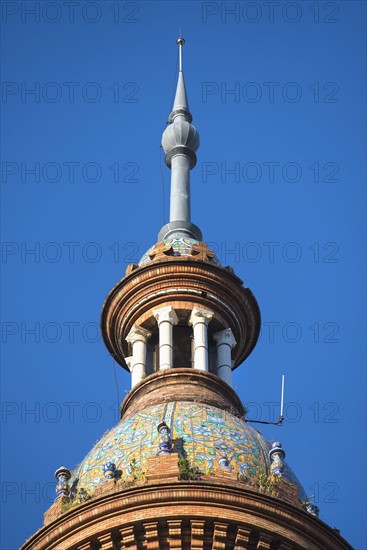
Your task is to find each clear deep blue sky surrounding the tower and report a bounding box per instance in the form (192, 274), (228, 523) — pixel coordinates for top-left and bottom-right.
(1, 0), (367, 550)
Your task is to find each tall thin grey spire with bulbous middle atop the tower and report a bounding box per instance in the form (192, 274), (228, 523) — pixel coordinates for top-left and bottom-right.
(158, 37), (202, 241)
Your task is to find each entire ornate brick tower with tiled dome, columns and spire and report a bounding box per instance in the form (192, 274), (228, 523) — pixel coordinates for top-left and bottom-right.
(23, 38), (350, 550)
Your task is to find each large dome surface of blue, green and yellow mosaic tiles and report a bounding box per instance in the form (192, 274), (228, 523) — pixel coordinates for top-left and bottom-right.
(70, 401), (305, 498)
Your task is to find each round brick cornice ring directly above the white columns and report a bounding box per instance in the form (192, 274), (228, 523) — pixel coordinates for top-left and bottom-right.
(101, 257), (260, 368)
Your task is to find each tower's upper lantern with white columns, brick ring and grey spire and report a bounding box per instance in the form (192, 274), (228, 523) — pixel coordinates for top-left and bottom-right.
(101, 38), (260, 388)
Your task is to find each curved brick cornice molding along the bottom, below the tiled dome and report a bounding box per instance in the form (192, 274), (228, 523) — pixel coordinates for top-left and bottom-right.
(21, 480), (352, 550)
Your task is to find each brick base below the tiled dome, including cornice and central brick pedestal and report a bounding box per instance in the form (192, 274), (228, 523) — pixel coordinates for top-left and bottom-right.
(21, 454), (352, 550)
